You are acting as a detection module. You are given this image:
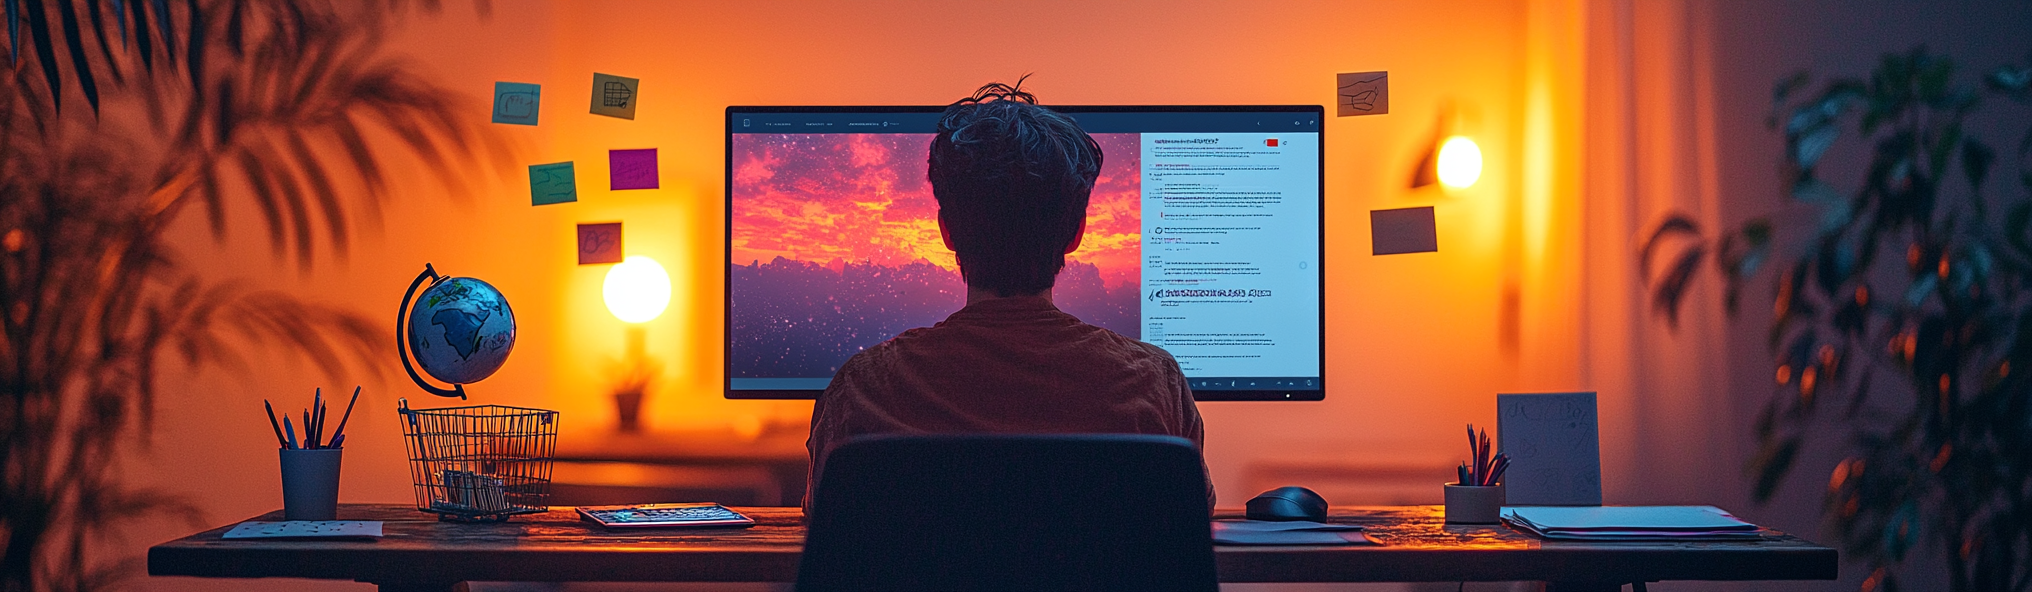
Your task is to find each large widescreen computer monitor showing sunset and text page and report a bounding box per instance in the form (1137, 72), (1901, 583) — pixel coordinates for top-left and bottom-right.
(725, 106), (1327, 401)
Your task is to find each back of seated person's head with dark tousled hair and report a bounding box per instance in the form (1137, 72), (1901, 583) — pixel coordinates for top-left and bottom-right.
(925, 75), (1101, 297)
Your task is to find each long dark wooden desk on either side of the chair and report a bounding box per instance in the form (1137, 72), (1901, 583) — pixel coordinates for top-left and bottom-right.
(148, 505), (1835, 592)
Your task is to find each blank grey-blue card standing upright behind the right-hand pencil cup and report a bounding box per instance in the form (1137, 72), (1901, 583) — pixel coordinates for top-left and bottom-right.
(1496, 393), (1601, 507)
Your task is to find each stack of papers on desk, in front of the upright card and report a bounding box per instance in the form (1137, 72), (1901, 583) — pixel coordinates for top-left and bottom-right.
(1504, 507), (1764, 541)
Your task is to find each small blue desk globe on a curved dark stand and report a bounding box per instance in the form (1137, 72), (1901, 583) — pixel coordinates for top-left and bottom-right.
(394, 264), (516, 399)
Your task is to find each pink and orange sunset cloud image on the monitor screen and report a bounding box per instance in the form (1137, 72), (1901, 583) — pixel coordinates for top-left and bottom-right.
(727, 134), (1142, 378)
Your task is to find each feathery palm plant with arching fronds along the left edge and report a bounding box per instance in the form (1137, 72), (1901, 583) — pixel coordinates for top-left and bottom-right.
(0, 0), (506, 592)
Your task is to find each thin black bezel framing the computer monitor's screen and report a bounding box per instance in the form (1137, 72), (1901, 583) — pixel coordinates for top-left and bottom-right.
(719, 106), (1327, 401)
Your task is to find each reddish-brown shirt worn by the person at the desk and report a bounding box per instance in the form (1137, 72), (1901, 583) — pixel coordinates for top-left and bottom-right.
(805, 297), (1211, 513)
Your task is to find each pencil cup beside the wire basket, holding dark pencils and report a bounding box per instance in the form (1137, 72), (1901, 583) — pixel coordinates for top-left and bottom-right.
(262, 387), (360, 521)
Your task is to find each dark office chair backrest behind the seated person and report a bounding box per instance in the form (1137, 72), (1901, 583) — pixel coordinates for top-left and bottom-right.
(797, 435), (1219, 592)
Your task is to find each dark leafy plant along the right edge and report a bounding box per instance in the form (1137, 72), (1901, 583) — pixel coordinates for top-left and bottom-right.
(1642, 49), (2032, 592)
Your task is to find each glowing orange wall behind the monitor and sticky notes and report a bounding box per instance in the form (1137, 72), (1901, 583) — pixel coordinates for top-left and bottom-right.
(143, 0), (1544, 588)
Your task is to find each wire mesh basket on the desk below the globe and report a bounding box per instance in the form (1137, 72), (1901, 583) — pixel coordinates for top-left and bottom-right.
(396, 399), (557, 523)
